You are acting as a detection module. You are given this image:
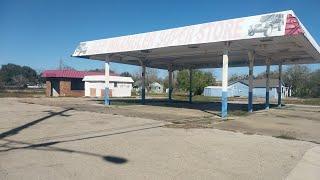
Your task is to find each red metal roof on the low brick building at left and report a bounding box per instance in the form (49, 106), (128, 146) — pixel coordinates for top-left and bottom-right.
(42, 70), (115, 78)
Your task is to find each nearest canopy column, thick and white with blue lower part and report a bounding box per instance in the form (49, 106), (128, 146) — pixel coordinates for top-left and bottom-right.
(221, 49), (229, 119)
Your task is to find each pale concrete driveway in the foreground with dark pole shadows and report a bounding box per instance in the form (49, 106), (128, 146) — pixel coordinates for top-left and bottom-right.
(0, 98), (316, 180)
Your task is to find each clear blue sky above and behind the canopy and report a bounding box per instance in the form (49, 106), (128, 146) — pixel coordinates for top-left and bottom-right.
(0, 0), (320, 79)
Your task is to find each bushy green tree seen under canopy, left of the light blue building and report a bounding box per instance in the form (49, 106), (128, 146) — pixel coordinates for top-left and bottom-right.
(177, 70), (215, 95)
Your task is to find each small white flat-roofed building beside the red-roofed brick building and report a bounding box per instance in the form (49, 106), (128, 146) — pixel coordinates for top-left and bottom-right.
(82, 75), (134, 97)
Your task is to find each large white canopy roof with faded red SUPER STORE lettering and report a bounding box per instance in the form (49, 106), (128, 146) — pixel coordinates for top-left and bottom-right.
(72, 10), (320, 69)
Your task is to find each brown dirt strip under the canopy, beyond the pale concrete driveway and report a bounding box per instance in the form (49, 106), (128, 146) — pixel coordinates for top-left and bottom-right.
(19, 98), (320, 143)
